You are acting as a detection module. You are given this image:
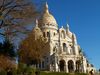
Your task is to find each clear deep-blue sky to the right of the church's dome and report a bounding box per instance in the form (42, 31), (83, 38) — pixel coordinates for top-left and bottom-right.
(33, 0), (100, 69)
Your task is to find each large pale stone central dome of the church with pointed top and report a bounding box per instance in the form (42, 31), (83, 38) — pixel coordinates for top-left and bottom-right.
(39, 3), (57, 27)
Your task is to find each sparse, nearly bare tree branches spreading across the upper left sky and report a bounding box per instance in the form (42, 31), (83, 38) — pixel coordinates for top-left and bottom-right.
(0, 0), (37, 40)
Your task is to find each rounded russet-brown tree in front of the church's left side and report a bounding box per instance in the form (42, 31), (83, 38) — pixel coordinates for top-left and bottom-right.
(19, 23), (49, 65)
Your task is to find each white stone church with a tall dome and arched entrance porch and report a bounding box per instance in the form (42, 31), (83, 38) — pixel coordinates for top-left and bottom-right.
(34, 3), (95, 73)
